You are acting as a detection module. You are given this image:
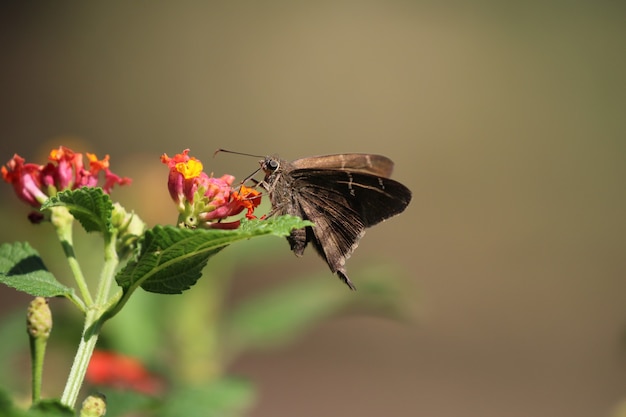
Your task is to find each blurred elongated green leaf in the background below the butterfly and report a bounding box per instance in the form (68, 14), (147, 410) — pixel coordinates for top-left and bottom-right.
(222, 267), (406, 360)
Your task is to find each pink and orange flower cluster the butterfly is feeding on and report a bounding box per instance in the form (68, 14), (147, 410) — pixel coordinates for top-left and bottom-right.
(161, 149), (261, 229)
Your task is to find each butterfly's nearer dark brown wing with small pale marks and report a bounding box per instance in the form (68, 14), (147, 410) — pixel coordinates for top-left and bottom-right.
(290, 169), (411, 289)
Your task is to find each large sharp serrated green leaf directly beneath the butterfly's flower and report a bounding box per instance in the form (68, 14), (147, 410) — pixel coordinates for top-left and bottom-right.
(116, 216), (311, 294)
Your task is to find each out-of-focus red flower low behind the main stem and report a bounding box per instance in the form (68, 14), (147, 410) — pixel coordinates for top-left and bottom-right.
(85, 350), (164, 395)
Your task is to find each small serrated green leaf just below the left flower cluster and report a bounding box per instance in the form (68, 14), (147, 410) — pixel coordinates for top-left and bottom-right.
(41, 187), (113, 233)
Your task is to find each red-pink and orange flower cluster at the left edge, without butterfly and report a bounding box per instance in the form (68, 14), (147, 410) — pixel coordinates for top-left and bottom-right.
(2, 146), (131, 220)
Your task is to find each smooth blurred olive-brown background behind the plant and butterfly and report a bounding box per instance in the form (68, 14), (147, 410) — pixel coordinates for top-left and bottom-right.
(0, 1), (626, 417)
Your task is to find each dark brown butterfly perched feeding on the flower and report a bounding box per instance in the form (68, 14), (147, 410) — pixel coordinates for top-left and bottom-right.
(260, 153), (411, 290)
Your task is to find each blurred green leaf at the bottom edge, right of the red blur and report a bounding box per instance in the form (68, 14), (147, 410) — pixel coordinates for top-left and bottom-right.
(158, 378), (256, 417)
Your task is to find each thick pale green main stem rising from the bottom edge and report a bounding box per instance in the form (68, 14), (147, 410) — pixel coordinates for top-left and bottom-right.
(61, 233), (119, 408)
